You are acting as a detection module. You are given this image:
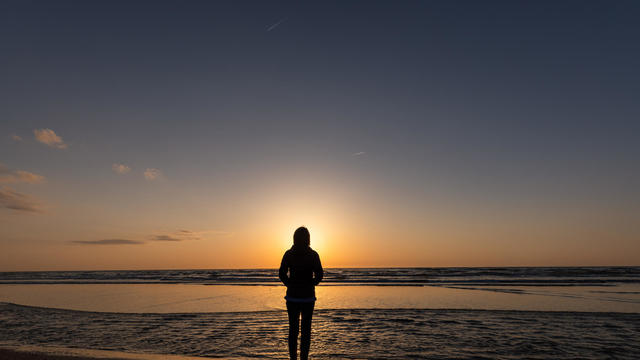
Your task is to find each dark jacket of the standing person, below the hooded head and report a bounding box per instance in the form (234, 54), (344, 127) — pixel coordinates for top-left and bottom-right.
(279, 245), (324, 299)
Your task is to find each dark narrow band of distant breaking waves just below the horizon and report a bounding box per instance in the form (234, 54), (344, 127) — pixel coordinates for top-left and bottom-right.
(0, 266), (640, 286)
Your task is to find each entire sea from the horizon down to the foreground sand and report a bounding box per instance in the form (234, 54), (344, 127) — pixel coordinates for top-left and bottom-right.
(0, 267), (640, 359)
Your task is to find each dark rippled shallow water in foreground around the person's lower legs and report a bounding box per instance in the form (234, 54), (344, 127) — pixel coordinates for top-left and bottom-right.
(0, 304), (640, 360)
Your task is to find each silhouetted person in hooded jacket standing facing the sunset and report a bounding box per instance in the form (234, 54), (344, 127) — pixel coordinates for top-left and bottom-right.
(279, 227), (324, 360)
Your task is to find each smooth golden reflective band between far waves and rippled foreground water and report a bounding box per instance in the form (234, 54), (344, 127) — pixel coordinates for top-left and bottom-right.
(0, 284), (640, 313)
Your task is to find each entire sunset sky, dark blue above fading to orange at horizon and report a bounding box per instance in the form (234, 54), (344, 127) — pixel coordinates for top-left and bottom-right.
(0, 0), (640, 271)
